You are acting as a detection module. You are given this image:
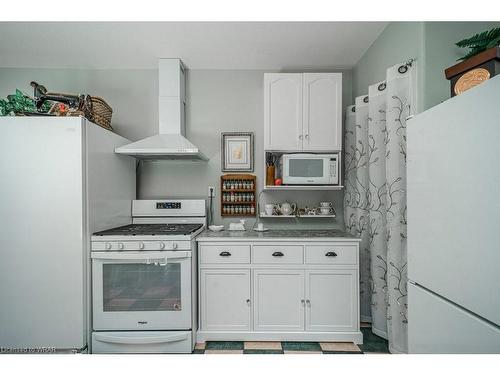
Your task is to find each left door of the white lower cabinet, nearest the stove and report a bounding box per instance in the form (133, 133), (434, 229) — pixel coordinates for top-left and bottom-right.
(200, 269), (251, 331)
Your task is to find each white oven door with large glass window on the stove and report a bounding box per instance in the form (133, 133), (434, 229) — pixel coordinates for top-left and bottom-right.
(91, 251), (192, 330)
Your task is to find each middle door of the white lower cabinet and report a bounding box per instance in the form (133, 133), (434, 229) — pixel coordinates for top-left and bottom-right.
(254, 269), (304, 331)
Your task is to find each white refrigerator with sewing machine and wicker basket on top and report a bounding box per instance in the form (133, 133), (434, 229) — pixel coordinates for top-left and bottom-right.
(0, 117), (136, 353)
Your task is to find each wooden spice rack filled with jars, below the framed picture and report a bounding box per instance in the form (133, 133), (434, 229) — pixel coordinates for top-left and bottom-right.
(220, 174), (257, 217)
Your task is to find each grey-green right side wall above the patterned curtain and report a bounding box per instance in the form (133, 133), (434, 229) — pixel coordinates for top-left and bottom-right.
(353, 22), (500, 112)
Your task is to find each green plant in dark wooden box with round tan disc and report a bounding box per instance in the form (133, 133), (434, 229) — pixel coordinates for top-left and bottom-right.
(444, 27), (500, 97)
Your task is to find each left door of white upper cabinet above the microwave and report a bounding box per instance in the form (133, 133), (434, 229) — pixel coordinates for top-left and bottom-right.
(264, 73), (303, 151)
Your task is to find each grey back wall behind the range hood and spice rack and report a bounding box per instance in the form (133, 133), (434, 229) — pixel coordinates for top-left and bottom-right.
(0, 68), (352, 229)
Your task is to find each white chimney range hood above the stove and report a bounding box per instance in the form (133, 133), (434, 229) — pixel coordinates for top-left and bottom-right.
(115, 59), (208, 160)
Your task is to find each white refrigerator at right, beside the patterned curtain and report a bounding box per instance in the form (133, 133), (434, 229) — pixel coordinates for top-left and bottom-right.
(407, 76), (500, 353)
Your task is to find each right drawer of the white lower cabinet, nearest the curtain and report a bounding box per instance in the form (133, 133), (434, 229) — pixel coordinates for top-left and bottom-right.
(306, 245), (358, 264)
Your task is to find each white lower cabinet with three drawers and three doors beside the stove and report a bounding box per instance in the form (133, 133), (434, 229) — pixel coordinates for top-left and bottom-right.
(197, 241), (362, 343)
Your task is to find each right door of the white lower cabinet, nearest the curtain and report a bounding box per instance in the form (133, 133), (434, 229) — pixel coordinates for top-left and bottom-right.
(306, 269), (359, 332)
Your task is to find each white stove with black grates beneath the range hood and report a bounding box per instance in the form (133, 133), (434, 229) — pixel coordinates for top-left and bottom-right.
(91, 199), (206, 353)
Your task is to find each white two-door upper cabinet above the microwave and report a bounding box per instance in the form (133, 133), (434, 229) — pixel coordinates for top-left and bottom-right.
(264, 73), (342, 151)
